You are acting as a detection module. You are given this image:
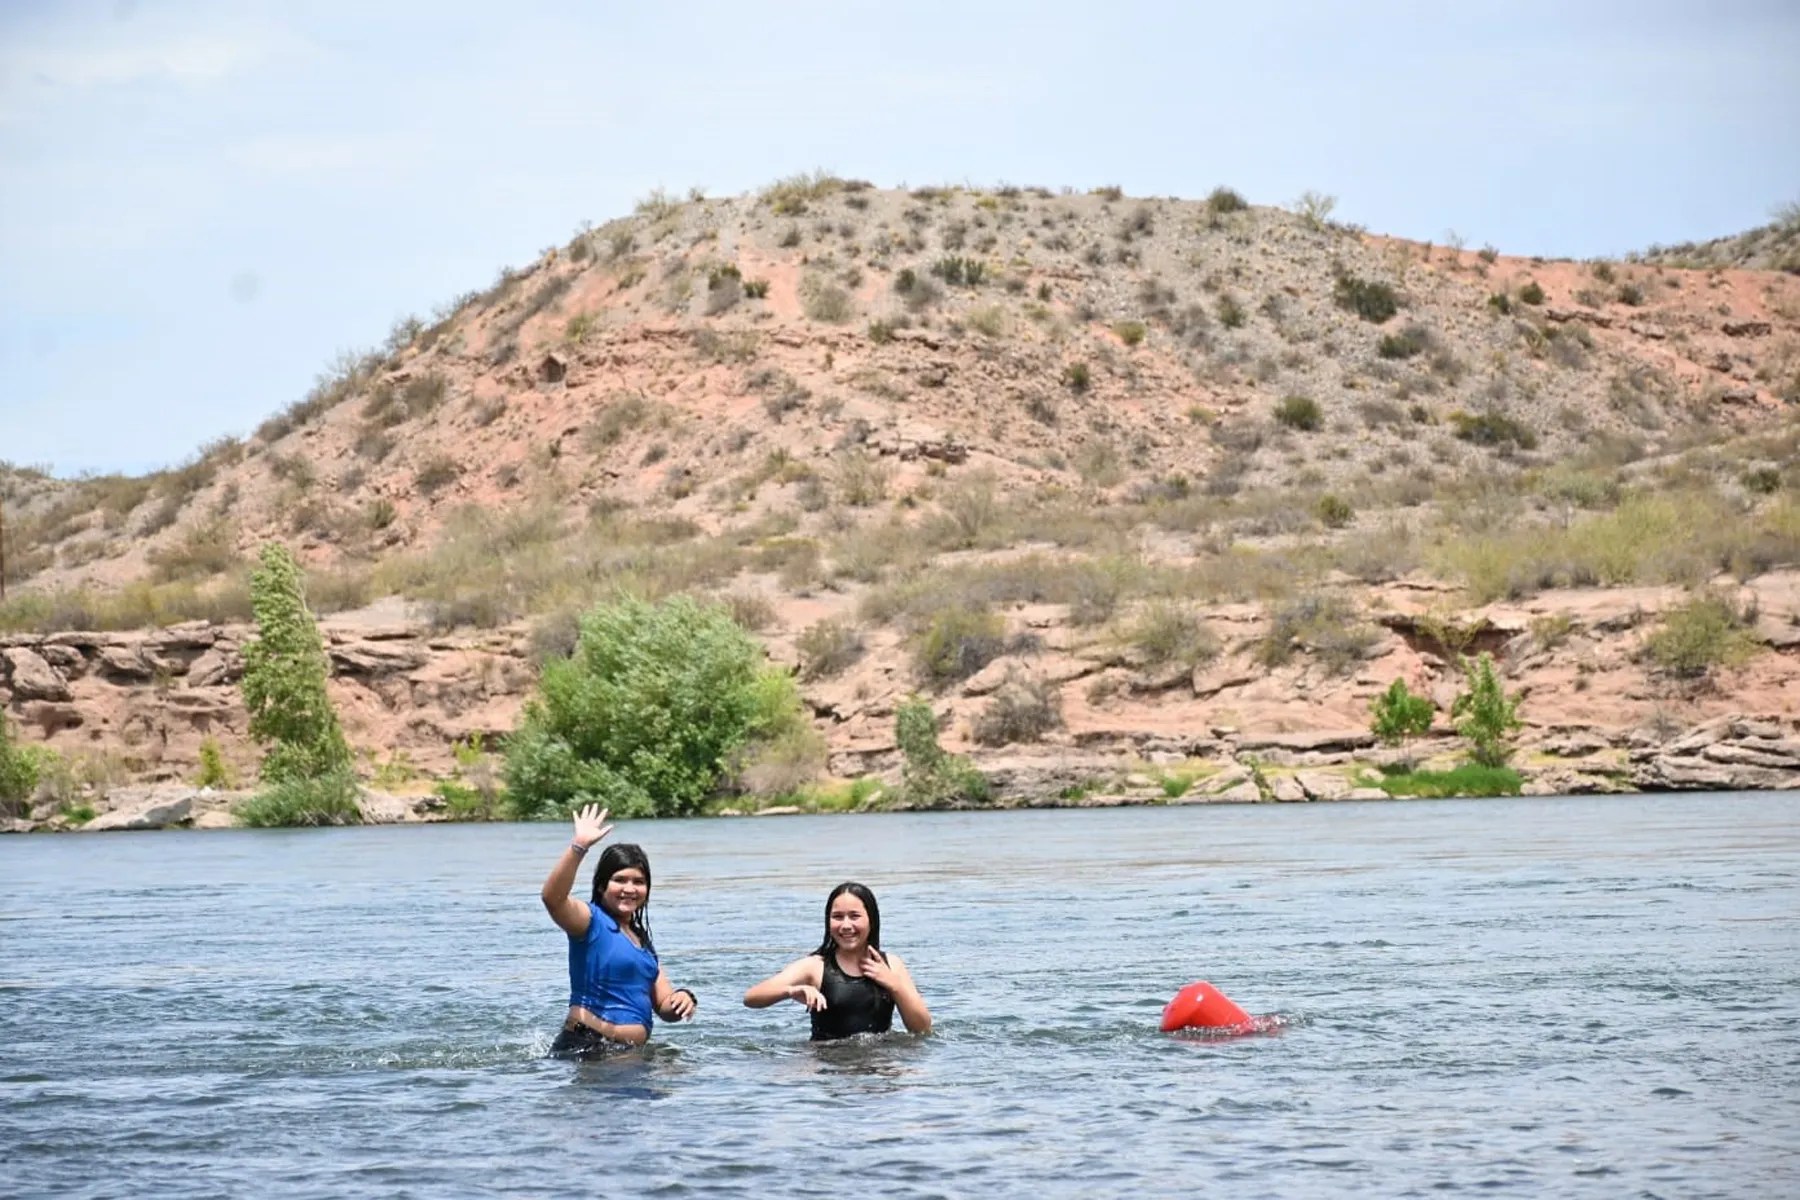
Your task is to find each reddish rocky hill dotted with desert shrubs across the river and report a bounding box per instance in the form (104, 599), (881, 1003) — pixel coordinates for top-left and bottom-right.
(0, 176), (1800, 816)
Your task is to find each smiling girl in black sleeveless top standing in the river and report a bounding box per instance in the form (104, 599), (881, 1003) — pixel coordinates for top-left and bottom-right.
(743, 883), (931, 1042)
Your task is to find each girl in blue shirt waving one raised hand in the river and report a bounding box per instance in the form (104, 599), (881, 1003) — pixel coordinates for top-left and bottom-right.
(542, 804), (695, 1058)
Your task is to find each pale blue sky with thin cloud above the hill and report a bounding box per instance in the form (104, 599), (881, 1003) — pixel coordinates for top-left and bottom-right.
(0, 0), (1800, 475)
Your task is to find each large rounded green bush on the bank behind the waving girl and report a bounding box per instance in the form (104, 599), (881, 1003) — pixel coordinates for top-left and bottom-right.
(504, 596), (805, 819)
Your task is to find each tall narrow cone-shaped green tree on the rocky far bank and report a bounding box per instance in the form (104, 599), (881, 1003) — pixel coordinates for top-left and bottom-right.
(243, 542), (353, 783)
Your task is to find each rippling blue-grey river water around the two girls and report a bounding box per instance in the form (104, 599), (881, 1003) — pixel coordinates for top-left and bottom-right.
(0, 793), (1800, 1198)
